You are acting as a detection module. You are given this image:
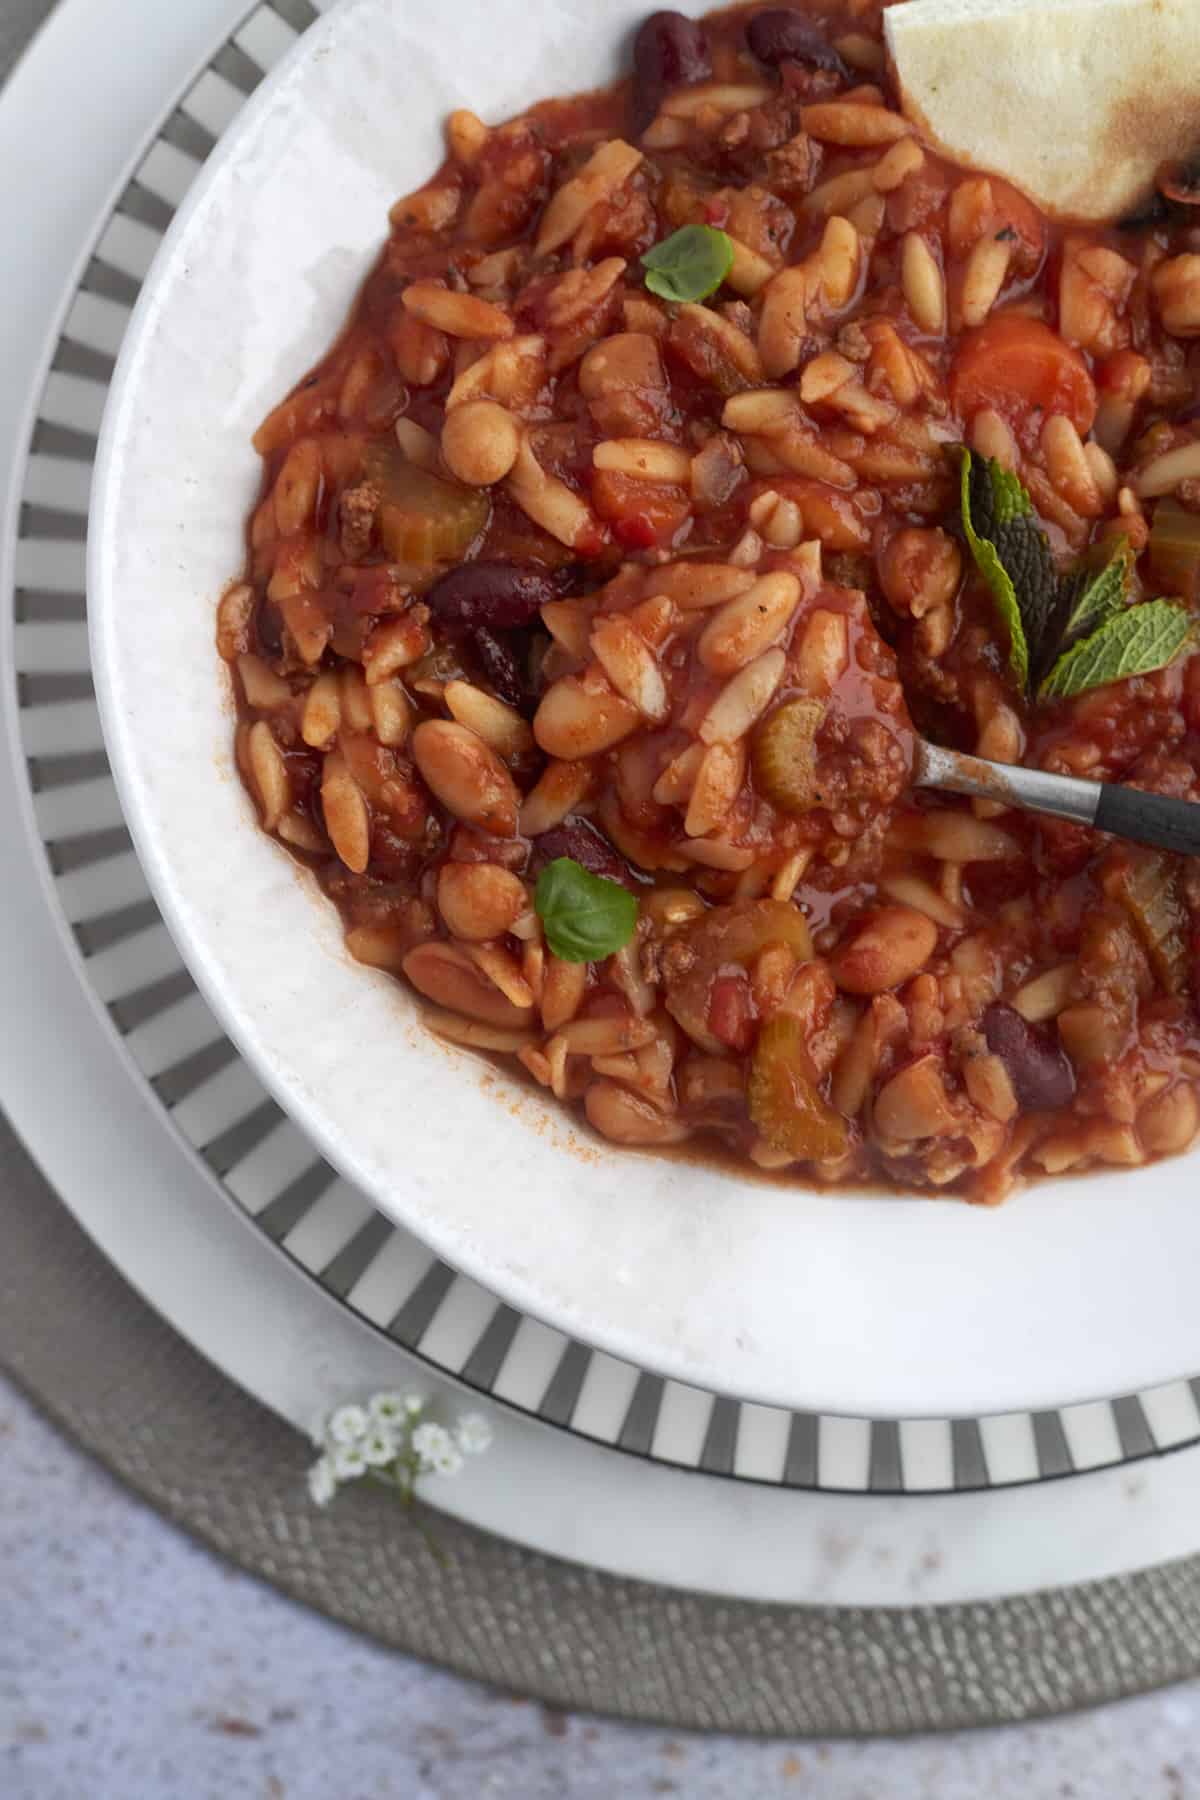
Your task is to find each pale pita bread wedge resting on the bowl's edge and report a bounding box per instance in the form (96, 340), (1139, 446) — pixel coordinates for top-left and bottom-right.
(885, 0), (1200, 220)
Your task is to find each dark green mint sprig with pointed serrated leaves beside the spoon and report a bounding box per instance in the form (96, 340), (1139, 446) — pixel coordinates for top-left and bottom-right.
(961, 446), (1195, 700)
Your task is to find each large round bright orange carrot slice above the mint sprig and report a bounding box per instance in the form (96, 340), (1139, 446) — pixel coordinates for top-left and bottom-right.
(950, 313), (1096, 437)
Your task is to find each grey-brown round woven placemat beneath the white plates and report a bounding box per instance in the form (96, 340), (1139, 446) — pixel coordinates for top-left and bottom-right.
(0, 1101), (1200, 1737)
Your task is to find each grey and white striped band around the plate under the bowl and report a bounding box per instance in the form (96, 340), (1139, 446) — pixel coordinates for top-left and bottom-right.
(13, 0), (1200, 1494)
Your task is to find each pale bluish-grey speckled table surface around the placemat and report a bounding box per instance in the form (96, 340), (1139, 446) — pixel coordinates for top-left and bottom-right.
(0, 0), (1200, 1800)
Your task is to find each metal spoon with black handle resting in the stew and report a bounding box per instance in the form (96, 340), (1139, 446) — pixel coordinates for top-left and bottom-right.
(912, 738), (1200, 857)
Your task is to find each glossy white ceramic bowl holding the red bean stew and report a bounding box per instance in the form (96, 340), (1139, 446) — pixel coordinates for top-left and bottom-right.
(88, 0), (1200, 1417)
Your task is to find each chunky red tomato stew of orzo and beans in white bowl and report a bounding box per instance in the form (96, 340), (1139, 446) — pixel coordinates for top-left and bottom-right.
(219, 0), (1200, 1202)
